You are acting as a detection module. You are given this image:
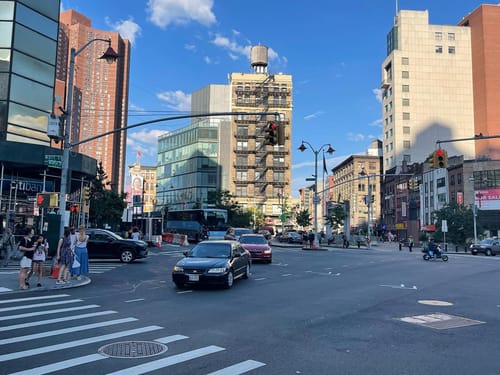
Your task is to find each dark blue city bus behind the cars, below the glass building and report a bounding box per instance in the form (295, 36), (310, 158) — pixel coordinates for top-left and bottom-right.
(165, 208), (229, 242)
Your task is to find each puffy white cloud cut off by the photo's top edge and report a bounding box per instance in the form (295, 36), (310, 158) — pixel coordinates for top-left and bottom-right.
(146, 0), (217, 29)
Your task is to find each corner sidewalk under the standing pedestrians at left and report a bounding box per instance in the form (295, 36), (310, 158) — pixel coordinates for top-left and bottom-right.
(0, 261), (92, 295)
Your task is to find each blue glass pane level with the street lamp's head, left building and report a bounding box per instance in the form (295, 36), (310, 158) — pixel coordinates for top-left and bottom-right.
(14, 24), (57, 65)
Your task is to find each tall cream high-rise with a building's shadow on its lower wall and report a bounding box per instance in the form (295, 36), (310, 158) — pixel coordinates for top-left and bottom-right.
(381, 10), (475, 170)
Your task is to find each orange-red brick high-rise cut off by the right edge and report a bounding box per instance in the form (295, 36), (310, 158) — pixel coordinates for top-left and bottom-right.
(459, 4), (500, 160)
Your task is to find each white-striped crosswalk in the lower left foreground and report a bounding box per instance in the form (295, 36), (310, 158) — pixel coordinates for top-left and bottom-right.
(0, 293), (265, 375)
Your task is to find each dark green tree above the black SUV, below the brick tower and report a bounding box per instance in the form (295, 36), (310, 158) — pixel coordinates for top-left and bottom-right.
(89, 162), (127, 228)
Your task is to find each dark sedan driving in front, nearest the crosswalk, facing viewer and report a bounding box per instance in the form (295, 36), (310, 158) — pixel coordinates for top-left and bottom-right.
(172, 240), (252, 289)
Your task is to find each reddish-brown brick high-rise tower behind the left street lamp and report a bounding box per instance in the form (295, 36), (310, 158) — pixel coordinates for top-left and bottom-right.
(55, 10), (130, 191)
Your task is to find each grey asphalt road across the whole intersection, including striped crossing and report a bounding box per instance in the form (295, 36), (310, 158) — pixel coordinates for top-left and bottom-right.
(0, 248), (500, 375)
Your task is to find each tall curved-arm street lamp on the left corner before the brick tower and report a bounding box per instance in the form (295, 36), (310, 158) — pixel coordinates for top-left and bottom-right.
(59, 38), (118, 236)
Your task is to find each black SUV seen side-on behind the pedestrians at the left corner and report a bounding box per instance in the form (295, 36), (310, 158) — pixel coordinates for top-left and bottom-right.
(85, 229), (148, 263)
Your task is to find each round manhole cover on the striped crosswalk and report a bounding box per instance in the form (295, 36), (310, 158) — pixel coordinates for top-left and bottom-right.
(98, 341), (168, 358)
